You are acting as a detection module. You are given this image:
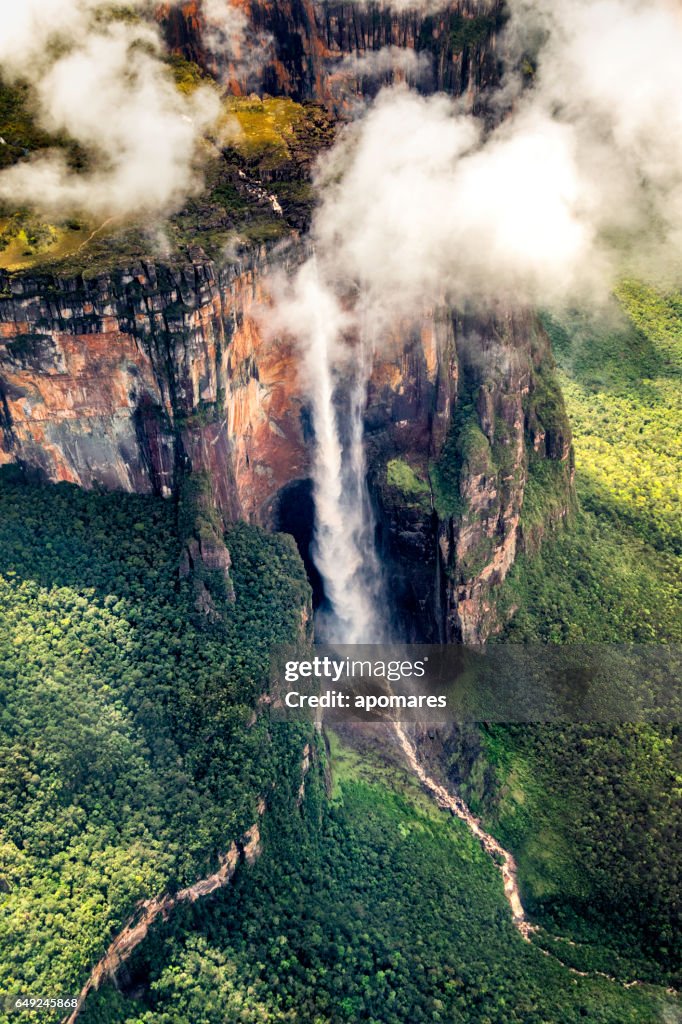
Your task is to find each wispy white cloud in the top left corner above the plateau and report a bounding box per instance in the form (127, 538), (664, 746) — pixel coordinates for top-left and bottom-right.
(0, 0), (219, 216)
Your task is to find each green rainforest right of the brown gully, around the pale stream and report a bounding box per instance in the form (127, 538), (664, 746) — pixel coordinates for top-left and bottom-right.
(27, 285), (680, 1024)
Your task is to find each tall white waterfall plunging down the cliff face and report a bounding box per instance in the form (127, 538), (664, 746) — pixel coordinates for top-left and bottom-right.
(290, 258), (386, 643)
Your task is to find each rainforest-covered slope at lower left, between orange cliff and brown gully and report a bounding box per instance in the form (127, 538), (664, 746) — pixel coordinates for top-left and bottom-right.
(0, 471), (308, 1019)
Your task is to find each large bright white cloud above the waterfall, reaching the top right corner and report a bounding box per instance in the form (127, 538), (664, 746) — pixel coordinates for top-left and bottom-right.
(294, 0), (682, 317)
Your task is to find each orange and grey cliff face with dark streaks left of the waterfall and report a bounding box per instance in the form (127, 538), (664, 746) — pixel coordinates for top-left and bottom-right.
(0, 251), (305, 520)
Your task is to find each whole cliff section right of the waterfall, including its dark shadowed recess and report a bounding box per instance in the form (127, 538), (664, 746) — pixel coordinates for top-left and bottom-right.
(368, 301), (573, 643)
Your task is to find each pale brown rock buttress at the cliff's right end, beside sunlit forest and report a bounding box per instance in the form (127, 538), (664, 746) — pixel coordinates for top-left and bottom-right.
(438, 311), (573, 642)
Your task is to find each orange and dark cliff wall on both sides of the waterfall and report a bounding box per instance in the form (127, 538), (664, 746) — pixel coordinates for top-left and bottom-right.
(0, 244), (571, 640)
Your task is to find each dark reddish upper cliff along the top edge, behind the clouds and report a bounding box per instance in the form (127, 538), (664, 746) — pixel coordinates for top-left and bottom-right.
(157, 0), (503, 111)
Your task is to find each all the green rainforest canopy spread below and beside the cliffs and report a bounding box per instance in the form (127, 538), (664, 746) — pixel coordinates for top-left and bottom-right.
(0, 276), (680, 1024)
